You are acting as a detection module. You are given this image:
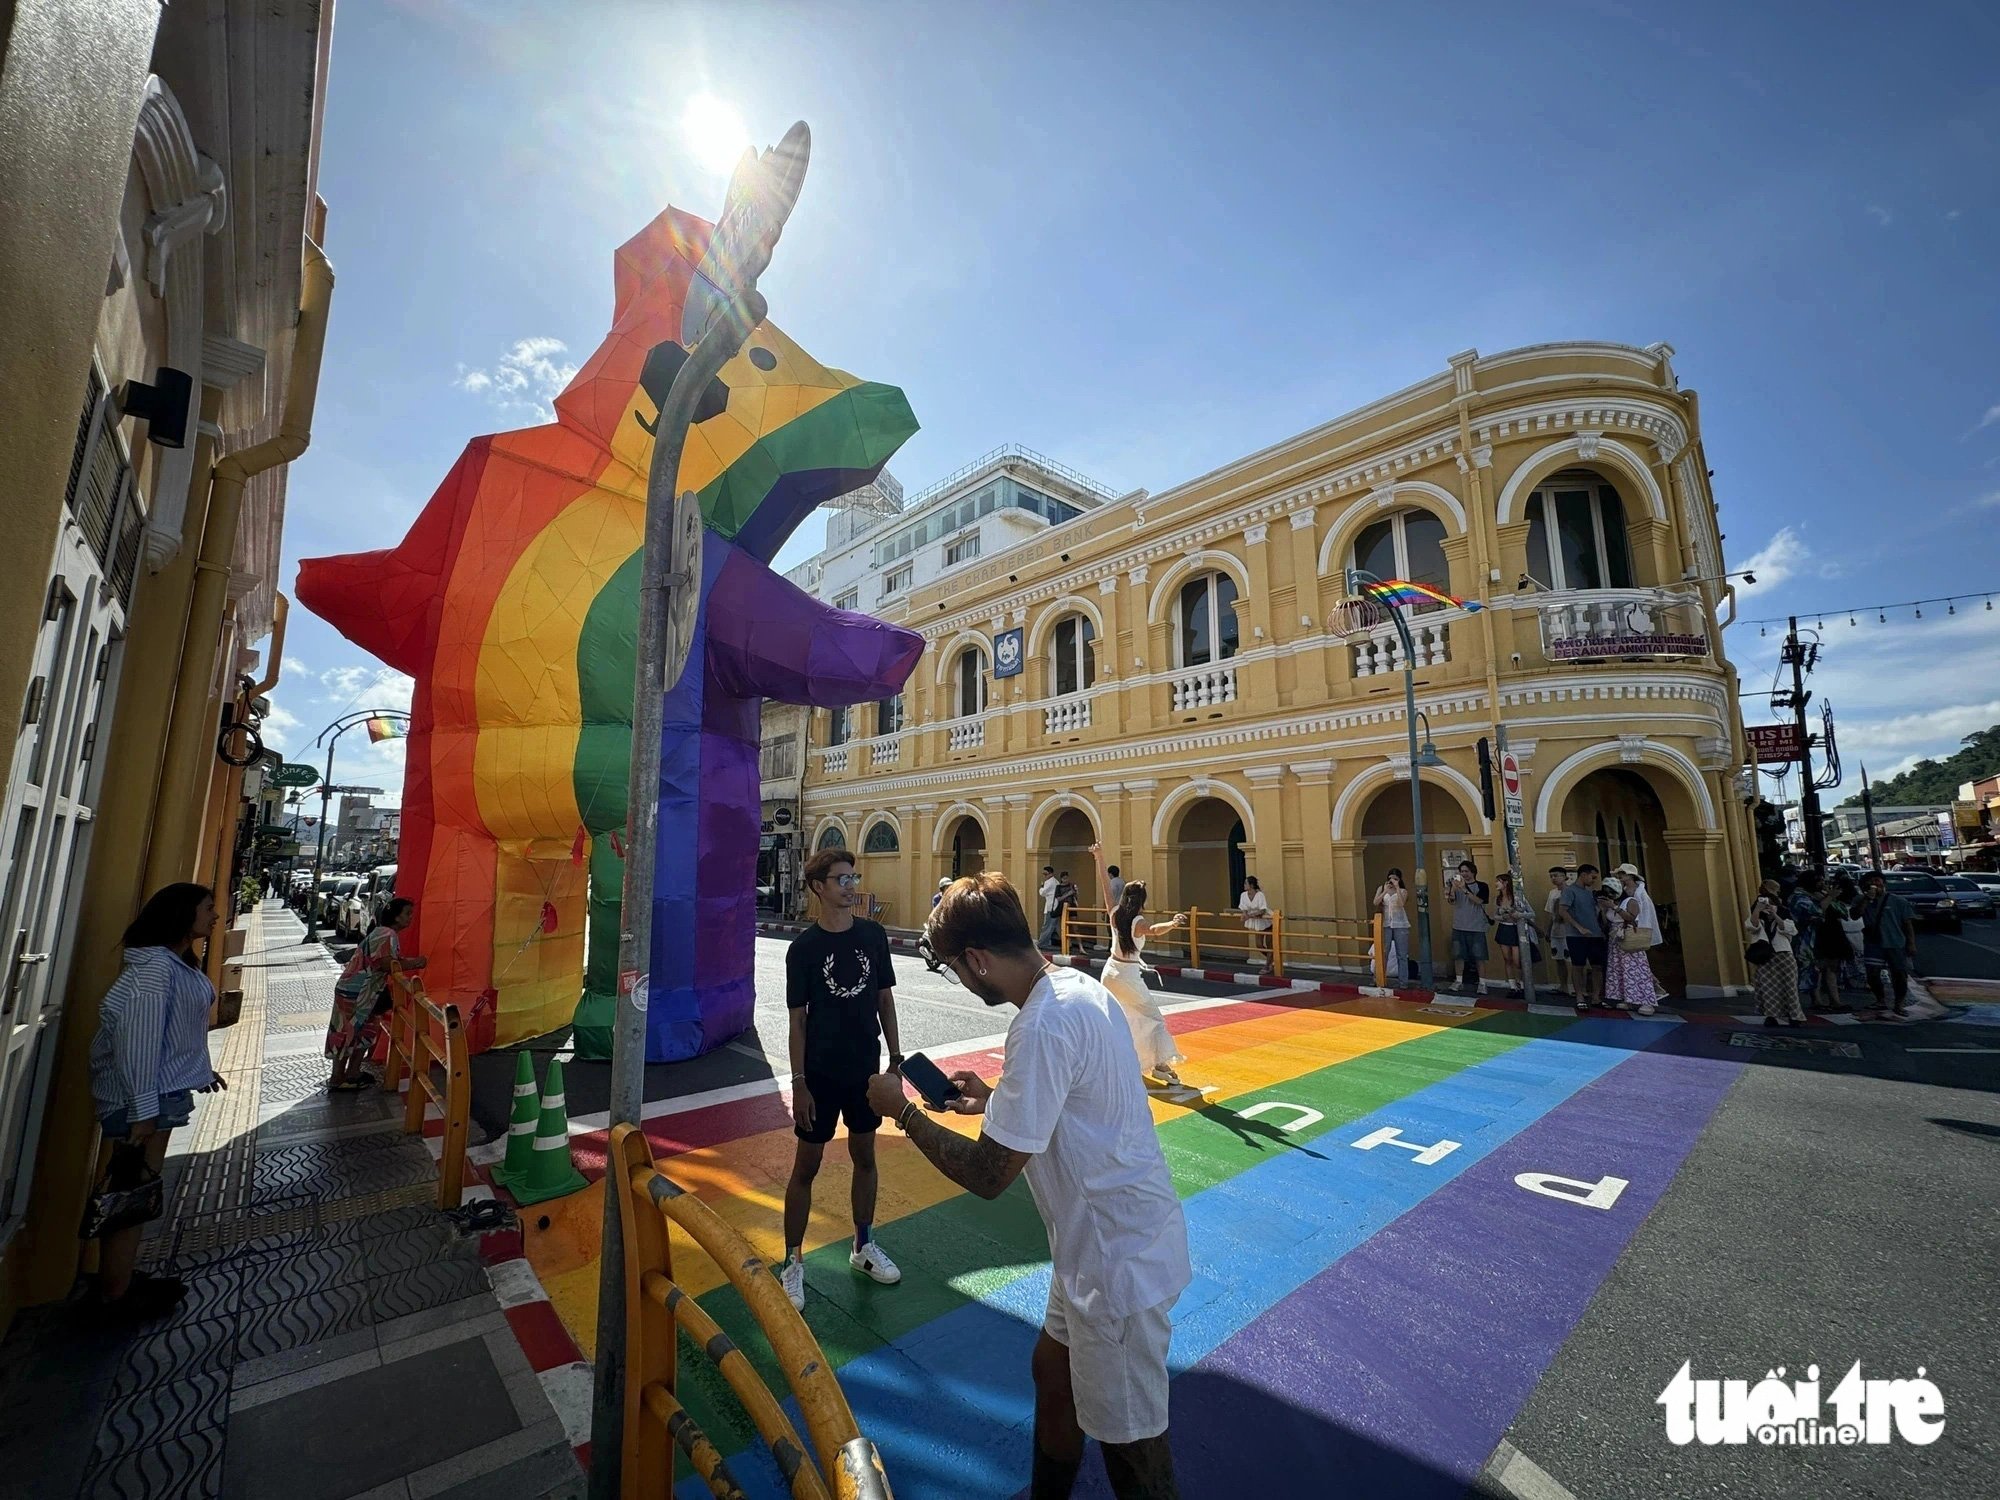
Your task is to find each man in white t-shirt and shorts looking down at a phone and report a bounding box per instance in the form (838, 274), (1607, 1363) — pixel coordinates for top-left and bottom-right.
(868, 874), (1194, 1500)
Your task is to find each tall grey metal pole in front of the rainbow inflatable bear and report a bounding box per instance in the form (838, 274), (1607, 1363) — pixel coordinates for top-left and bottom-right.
(590, 120), (812, 1500)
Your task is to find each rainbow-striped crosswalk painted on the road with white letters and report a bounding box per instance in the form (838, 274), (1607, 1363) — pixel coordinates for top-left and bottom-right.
(528, 1000), (1736, 1500)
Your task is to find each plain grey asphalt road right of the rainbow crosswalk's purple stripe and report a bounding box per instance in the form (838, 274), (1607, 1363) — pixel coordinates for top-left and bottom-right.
(1482, 1024), (2000, 1500)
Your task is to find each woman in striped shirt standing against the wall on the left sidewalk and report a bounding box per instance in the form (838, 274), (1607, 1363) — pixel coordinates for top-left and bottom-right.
(90, 884), (228, 1318)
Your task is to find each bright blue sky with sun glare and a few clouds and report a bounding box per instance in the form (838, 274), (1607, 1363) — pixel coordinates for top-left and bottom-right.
(268, 0), (2000, 812)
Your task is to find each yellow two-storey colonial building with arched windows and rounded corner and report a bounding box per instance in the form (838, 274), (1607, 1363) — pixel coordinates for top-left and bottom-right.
(802, 344), (1756, 996)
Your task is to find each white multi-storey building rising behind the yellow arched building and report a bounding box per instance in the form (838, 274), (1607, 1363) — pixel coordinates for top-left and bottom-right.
(758, 444), (1144, 912)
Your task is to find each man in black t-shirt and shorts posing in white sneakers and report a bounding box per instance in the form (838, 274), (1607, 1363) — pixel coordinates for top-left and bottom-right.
(778, 848), (902, 1310)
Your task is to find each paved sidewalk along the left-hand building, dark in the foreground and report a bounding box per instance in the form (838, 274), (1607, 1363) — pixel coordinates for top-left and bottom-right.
(0, 902), (584, 1500)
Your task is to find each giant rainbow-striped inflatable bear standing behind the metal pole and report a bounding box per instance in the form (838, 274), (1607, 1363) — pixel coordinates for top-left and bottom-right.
(298, 208), (922, 1062)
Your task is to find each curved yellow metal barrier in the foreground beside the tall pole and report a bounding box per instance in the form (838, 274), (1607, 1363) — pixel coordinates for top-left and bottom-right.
(610, 1124), (890, 1500)
